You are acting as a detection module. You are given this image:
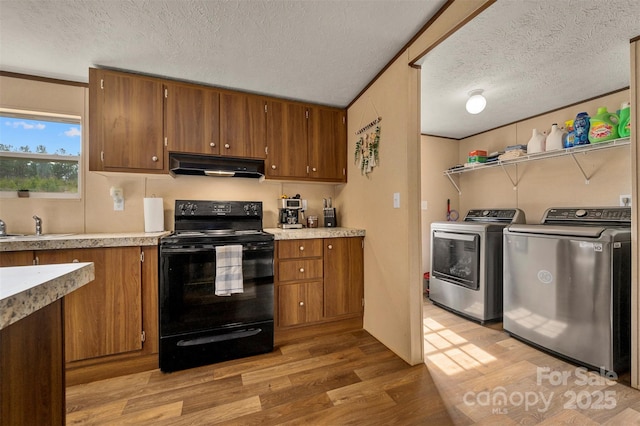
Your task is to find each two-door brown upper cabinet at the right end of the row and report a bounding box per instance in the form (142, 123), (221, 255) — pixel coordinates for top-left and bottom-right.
(265, 100), (347, 182)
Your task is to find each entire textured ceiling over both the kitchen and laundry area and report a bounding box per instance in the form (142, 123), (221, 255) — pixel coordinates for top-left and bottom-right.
(0, 0), (640, 138)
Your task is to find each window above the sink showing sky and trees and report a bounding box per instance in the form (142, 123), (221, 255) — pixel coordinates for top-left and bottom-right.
(0, 108), (82, 198)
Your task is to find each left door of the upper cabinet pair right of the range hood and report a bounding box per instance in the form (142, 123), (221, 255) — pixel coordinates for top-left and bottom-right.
(265, 101), (309, 178)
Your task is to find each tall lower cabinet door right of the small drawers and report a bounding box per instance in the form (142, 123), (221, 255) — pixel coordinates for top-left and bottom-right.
(324, 238), (364, 318)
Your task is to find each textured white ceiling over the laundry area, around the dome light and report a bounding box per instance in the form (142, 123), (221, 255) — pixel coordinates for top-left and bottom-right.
(421, 0), (640, 139)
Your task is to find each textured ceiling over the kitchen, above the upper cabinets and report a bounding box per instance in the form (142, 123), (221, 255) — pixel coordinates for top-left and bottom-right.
(0, 0), (445, 107)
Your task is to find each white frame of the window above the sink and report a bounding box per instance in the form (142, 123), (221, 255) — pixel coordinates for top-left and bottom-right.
(0, 107), (85, 200)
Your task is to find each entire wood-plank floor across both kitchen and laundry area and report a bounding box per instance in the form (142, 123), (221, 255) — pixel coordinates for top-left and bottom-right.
(67, 301), (640, 426)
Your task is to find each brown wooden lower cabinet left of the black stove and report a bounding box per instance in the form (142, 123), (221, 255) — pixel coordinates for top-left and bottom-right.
(0, 246), (158, 385)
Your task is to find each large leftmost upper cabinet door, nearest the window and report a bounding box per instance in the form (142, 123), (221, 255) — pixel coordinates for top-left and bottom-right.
(96, 71), (164, 171)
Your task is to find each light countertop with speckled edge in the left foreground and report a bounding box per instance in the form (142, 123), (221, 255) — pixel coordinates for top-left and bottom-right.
(0, 262), (95, 330)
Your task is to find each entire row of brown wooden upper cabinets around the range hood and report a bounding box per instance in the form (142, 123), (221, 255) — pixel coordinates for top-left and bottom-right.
(89, 68), (347, 182)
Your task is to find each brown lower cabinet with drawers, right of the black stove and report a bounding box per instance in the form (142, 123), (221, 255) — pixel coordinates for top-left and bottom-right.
(275, 237), (364, 341)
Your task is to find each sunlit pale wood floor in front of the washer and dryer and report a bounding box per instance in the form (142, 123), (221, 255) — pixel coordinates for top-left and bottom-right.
(423, 301), (640, 426)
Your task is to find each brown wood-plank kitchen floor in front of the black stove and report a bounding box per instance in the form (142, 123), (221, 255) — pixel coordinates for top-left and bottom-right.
(67, 322), (452, 425)
